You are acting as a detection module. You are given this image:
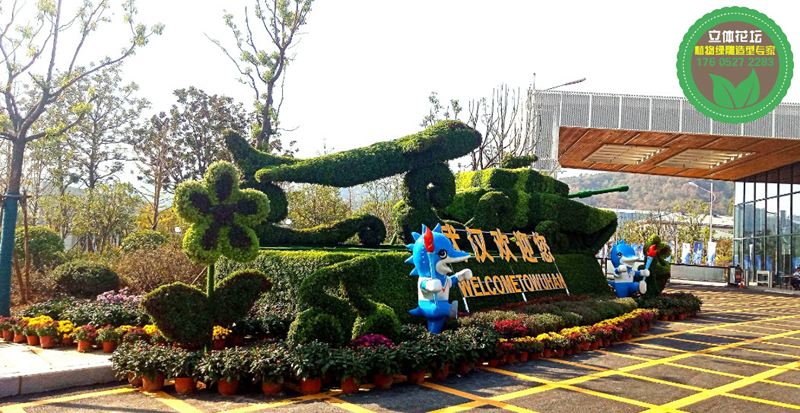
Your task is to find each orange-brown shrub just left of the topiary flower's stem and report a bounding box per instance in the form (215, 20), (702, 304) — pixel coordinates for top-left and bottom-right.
(113, 243), (204, 293)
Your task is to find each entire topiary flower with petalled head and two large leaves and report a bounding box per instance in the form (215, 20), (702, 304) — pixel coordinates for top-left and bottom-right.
(142, 162), (272, 347)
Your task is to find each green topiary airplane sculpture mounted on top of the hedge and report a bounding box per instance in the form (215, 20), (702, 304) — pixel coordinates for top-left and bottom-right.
(226, 121), (481, 246)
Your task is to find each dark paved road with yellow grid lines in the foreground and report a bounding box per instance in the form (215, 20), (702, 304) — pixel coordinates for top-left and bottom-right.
(0, 289), (800, 413)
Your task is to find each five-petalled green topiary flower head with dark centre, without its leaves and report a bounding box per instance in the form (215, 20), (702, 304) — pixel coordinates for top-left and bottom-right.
(175, 162), (269, 265)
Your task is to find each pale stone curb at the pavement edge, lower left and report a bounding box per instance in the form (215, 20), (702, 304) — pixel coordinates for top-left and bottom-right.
(0, 363), (119, 398)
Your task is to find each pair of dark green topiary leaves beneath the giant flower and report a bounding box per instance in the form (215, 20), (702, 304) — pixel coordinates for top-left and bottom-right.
(142, 270), (272, 347)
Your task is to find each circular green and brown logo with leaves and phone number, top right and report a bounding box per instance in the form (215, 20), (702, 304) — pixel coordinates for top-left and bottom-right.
(677, 7), (794, 123)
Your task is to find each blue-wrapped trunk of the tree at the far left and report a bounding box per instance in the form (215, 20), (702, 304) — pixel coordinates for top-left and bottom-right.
(0, 137), (25, 317)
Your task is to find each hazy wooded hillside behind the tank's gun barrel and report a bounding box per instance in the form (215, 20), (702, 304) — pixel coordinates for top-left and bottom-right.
(561, 172), (733, 215)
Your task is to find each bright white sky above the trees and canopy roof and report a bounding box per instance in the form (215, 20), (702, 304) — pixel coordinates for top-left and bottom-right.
(17, 0), (800, 180)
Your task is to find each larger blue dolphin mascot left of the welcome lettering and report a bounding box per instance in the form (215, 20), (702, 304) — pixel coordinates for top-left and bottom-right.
(406, 225), (472, 334)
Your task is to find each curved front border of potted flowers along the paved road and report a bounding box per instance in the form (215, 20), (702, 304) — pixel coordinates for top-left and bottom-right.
(112, 300), (700, 394)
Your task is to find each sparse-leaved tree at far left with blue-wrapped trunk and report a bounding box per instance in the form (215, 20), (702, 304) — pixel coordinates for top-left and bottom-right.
(0, 0), (163, 316)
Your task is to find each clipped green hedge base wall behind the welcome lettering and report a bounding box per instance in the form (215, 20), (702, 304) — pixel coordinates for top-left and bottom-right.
(216, 250), (611, 323)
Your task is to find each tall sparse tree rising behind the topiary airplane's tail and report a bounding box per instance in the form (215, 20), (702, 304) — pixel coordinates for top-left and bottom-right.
(209, 0), (312, 152)
